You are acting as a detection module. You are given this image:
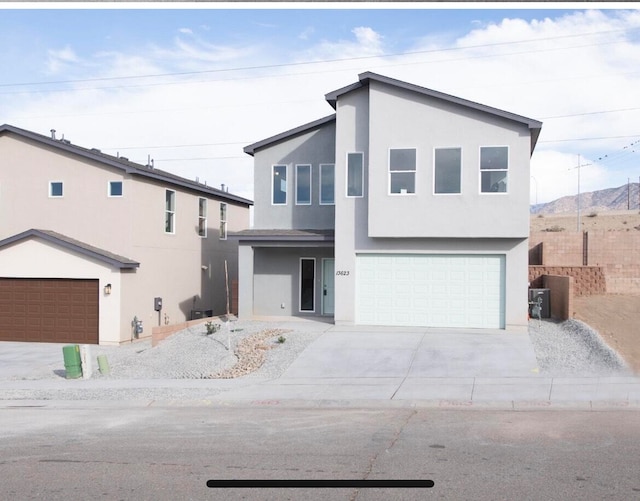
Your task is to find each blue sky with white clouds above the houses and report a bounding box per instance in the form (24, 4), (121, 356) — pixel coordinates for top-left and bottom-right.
(0, 3), (640, 204)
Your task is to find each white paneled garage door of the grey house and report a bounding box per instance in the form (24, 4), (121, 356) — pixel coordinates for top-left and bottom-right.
(356, 254), (505, 329)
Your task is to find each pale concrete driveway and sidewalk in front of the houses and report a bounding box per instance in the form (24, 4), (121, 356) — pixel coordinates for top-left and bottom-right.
(0, 324), (640, 409)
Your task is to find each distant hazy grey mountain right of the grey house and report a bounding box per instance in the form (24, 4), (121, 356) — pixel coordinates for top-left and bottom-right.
(531, 183), (640, 214)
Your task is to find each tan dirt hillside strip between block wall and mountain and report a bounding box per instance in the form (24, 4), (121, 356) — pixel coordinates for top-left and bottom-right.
(531, 210), (640, 232)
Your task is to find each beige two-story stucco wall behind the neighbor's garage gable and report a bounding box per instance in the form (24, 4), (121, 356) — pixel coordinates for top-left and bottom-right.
(0, 131), (249, 342)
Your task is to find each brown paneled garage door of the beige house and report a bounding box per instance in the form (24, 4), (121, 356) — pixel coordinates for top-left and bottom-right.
(0, 278), (98, 344)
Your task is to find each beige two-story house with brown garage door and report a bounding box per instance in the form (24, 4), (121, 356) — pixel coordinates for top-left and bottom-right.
(0, 125), (252, 344)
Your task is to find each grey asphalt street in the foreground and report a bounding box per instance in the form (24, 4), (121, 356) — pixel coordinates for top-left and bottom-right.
(0, 402), (640, 501)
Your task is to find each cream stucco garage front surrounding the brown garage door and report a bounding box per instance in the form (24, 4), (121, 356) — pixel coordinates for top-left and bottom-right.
(0, 239), (123, 345)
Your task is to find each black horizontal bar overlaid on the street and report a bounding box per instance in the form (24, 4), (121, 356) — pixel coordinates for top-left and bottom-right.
(207, 480), (435, 489)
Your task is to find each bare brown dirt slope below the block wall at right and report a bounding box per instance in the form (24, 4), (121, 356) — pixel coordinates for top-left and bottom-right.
(573, 294), (640, 374)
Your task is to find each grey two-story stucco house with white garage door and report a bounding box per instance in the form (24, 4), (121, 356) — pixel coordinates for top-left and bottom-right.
(235, 73), (542, 328)
